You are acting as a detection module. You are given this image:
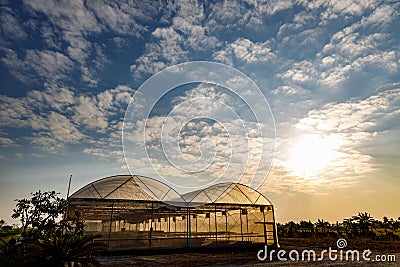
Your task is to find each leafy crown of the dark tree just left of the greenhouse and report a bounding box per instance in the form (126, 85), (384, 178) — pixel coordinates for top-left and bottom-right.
(11, 190), (67, 237)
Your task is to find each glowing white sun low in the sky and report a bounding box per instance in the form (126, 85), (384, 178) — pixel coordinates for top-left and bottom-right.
(287, 134), (340, 180)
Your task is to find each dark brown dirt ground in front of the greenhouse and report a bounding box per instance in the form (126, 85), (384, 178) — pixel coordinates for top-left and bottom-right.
(97, 239), (400, 267)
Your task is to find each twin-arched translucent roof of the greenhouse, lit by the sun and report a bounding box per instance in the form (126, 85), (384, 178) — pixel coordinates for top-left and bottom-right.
(69, 175), (272, 206)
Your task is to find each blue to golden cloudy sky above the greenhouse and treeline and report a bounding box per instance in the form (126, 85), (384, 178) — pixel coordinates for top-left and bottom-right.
(0, 0), (400, 225)
